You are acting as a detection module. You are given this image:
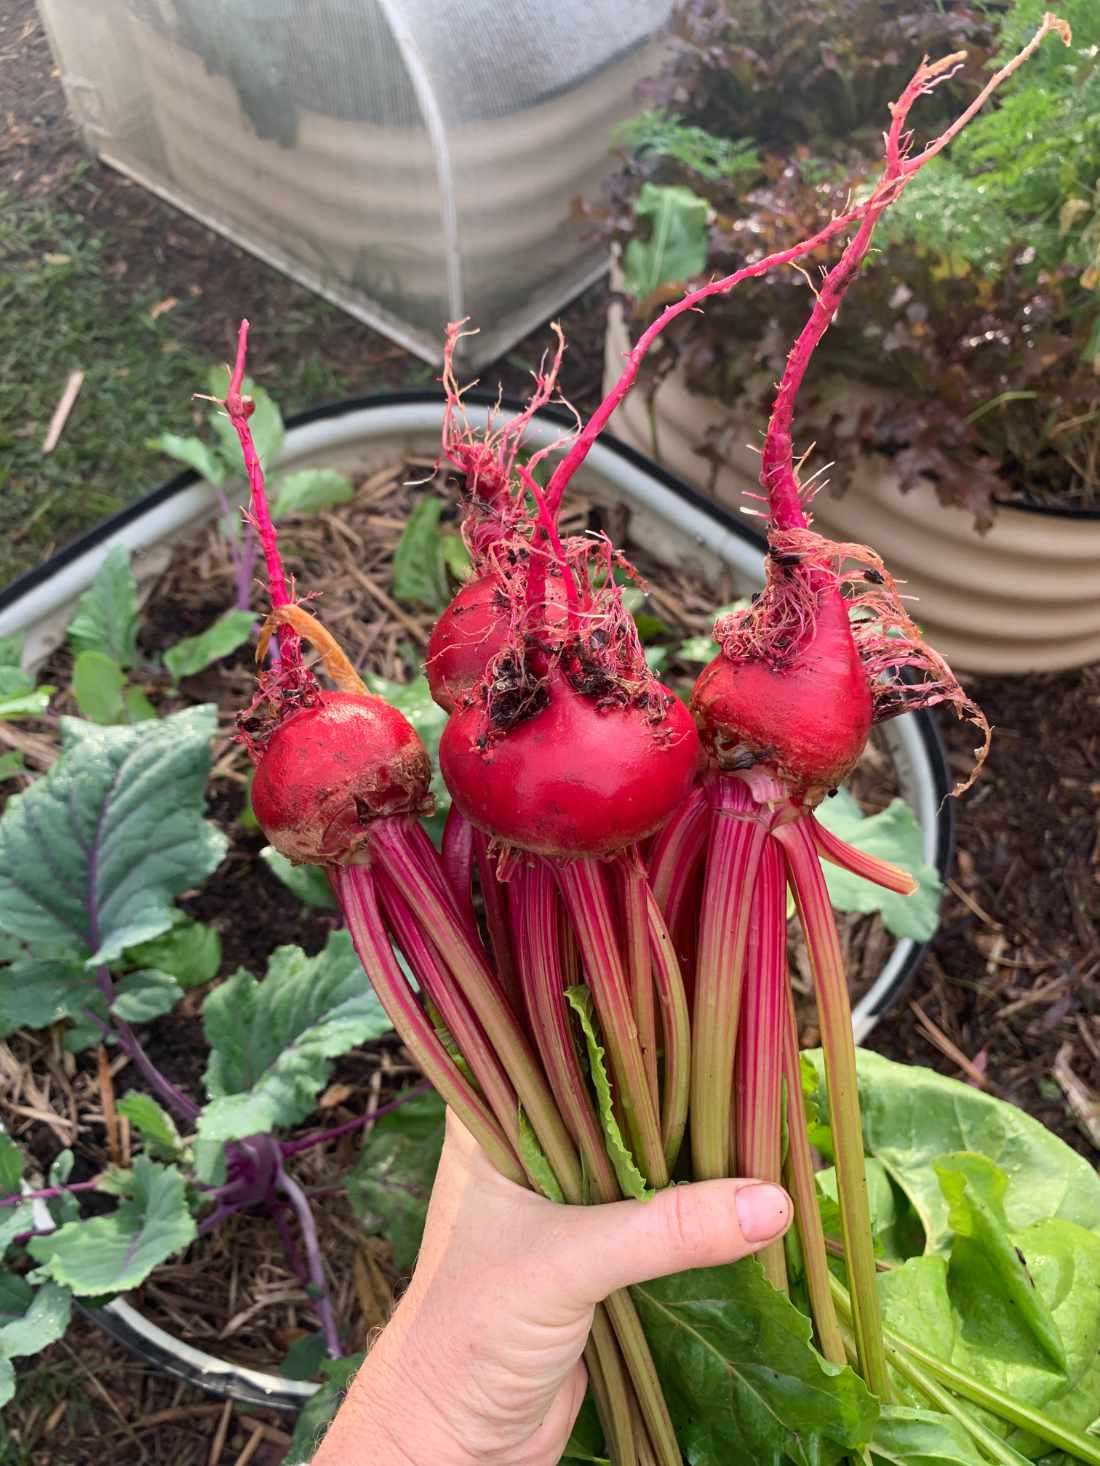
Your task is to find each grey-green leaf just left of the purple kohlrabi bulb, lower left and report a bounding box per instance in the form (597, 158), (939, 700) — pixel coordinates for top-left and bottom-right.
(26, 1155), (195, 1297)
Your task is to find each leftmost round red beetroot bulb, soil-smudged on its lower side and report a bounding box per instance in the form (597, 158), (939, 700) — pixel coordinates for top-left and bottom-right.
(252, 692), (431, 865)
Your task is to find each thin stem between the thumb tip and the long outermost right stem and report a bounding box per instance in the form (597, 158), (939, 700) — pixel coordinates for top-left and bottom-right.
(780, 984), (848, 1365)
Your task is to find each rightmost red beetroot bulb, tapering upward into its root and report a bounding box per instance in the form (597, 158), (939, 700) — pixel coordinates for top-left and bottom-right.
(692, 592), (873, 805)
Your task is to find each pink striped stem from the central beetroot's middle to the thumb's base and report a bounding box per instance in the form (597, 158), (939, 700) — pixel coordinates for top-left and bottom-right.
(554, 859), (669, 1186)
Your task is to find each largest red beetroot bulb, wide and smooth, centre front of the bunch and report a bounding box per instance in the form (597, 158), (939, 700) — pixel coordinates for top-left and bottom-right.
(440, 671), (700, 859)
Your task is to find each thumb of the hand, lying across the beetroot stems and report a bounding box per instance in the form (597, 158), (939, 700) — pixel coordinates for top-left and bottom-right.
(547, 1180), (792, 1306)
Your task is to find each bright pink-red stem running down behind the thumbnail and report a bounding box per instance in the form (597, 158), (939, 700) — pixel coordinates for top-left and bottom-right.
(733, 840), (788, 1293)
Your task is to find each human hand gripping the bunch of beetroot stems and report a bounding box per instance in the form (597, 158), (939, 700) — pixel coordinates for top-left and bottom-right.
(314, 1111), (791, 1466)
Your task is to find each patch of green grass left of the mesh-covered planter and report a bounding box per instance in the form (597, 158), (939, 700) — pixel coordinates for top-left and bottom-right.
(0, 179), (434, 586)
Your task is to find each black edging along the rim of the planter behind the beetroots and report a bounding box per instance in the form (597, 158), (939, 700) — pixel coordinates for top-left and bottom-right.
(0, 388), (956, 1410)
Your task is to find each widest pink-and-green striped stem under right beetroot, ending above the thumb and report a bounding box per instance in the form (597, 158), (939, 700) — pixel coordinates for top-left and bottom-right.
(691, 774), (767, 1180)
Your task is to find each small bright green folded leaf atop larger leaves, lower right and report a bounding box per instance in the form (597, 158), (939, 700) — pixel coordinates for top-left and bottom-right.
(934, 1152), (1067, 1372)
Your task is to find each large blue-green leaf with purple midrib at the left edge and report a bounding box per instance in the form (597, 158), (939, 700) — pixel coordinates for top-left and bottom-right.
(0, 707), (226, 963)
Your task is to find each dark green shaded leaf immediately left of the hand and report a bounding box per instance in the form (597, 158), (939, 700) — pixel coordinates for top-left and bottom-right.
(345, 1094), (446, 1272)
